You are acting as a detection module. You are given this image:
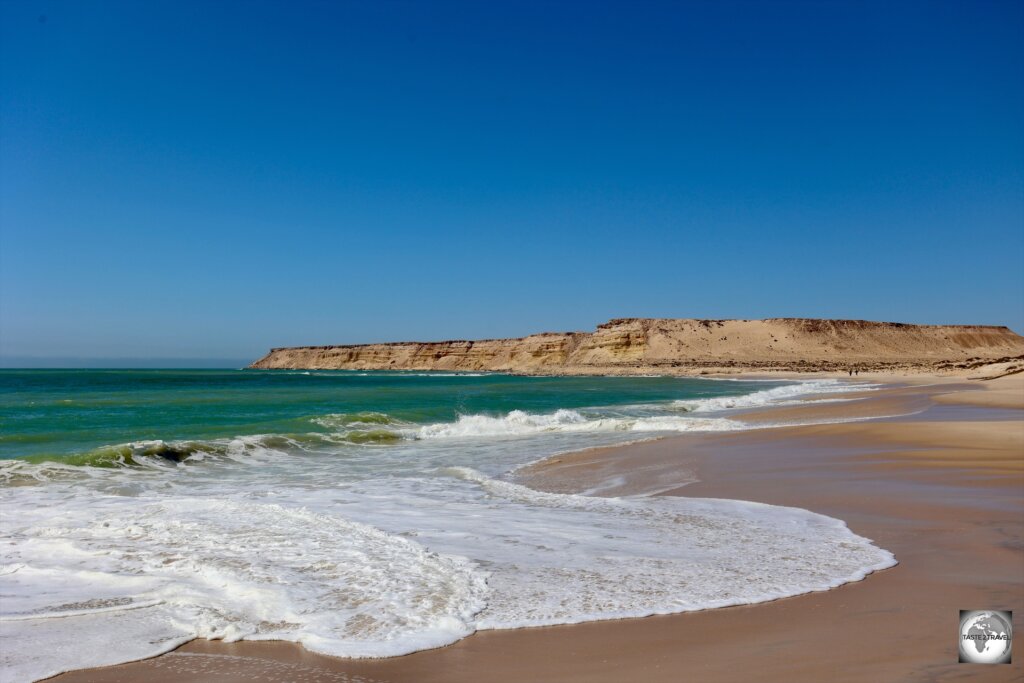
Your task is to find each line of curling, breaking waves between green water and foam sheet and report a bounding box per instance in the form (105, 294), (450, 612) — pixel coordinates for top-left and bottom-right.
(0, 380), (876, 483)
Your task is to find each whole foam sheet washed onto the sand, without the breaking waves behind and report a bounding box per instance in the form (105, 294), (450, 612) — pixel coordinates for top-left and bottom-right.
(0, 467), (894, 680)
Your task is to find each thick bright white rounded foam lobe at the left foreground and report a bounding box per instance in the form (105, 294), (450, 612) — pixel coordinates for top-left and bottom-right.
(0, 497), (486, 680)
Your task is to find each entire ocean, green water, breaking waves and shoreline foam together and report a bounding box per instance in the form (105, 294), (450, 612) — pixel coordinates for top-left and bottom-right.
(0, 370), (894, 681)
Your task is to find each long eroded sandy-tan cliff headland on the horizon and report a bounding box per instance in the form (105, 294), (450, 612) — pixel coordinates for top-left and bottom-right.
(251, 318), (1024, 374)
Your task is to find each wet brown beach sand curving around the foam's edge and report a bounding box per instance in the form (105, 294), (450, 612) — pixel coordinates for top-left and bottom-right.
(44, 375), (1024, 683)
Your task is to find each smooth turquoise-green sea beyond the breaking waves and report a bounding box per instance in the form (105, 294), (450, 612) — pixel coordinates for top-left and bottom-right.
(0, 370), (783, 459)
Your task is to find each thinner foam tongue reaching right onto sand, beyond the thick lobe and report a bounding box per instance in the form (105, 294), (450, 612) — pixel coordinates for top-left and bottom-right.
(432, 468), (895, 629)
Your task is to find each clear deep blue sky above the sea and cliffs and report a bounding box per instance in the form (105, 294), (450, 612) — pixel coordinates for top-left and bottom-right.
(0, 0), (1024, 366)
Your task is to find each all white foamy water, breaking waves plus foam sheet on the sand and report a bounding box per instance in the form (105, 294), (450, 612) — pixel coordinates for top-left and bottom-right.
(0, 376), (895, 681)
